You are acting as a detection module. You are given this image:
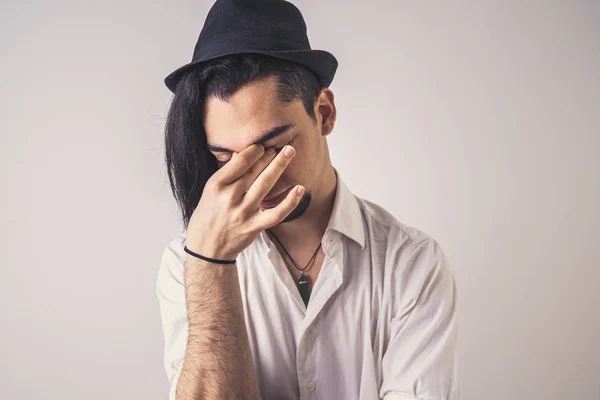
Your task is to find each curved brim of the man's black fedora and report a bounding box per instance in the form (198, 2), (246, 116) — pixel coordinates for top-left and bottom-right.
(165, 49), (338, 93)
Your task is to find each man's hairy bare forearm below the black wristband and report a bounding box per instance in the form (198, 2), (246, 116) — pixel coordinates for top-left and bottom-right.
(176, 256), (260, 400)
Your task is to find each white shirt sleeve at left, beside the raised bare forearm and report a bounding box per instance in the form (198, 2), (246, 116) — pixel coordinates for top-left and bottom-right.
(156, 235), (188, 400)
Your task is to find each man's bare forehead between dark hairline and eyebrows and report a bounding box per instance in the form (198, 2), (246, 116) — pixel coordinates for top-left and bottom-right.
(204, 78), (304, 151)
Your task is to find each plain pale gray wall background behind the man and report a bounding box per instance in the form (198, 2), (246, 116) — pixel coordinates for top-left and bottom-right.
(0, 0), (600, 400)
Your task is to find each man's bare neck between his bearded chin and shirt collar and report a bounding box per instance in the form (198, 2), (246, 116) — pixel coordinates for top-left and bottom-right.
(270, 166), (337, 247)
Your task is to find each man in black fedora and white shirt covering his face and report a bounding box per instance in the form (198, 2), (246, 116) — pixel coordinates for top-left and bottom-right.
(156, 0), (459, 400)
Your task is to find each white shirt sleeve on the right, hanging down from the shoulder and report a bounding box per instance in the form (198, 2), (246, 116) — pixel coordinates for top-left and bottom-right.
(380, 238), (460, 400)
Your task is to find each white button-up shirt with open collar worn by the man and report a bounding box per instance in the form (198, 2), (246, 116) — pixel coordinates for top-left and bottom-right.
(156, 170), (459, 400)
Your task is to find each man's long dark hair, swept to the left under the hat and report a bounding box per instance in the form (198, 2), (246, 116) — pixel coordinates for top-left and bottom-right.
(165, 54), (321, 229)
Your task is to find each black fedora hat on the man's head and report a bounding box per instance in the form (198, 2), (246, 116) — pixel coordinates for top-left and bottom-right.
(165, 0), (338, 93)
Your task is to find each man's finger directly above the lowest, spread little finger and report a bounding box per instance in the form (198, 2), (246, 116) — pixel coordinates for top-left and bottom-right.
(243, 145), (296, 209)
